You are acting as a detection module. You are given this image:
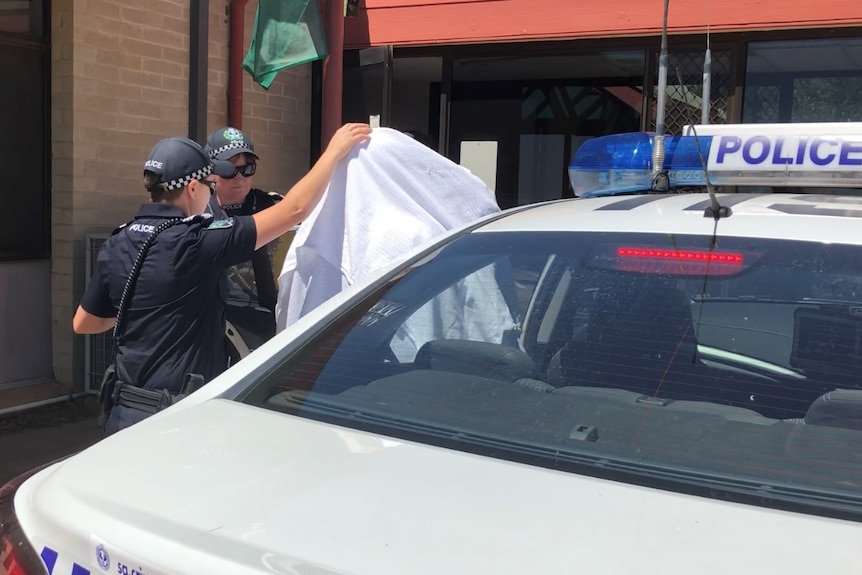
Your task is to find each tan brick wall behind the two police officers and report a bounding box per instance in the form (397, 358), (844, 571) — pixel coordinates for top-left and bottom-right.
(52, 0), (310, 386)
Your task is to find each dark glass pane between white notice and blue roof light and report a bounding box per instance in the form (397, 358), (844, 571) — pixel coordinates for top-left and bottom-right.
(448, 50), (645, 208)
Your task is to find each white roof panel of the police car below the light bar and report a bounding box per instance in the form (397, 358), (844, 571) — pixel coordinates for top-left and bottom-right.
(476, 193), (862, 245)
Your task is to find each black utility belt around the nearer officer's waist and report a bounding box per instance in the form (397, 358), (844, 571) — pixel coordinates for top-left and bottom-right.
(98, 364), (204, 430)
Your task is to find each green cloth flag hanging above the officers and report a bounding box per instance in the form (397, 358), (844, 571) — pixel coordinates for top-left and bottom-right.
(242, 0), (326, 89)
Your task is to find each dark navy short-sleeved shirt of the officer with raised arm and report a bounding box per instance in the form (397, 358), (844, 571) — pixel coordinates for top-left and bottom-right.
(81, 204), (257, 393)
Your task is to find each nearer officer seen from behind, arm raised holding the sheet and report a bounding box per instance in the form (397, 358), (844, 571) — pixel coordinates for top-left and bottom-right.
(72, 124), (371, 433)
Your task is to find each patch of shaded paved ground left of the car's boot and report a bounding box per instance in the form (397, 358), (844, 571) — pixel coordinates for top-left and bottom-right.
(0, 397), (102, 484)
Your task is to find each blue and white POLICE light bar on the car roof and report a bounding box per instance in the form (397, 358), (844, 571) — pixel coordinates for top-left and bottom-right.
(569, 129), (862, 197)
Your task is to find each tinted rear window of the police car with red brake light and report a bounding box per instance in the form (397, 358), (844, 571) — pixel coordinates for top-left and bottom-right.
(242, 232), (862, 514)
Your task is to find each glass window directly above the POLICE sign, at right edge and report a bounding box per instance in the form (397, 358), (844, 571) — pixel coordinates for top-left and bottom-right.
(743, 38), (862, 123)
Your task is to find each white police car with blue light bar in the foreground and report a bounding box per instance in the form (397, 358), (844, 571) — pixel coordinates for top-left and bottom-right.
(0, 125), (862, 575)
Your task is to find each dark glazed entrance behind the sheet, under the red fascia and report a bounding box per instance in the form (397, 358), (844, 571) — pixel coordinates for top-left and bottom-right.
(343, 47), (646, 209)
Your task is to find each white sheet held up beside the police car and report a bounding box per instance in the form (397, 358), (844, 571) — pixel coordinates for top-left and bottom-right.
(276, 128), (513, 357)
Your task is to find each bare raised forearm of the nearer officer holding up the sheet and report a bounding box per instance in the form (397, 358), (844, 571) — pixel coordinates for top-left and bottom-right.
(252, 124), (371, 250)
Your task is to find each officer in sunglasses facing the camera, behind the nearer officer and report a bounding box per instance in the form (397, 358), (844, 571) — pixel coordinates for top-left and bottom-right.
(204, 126), (282, 320)
